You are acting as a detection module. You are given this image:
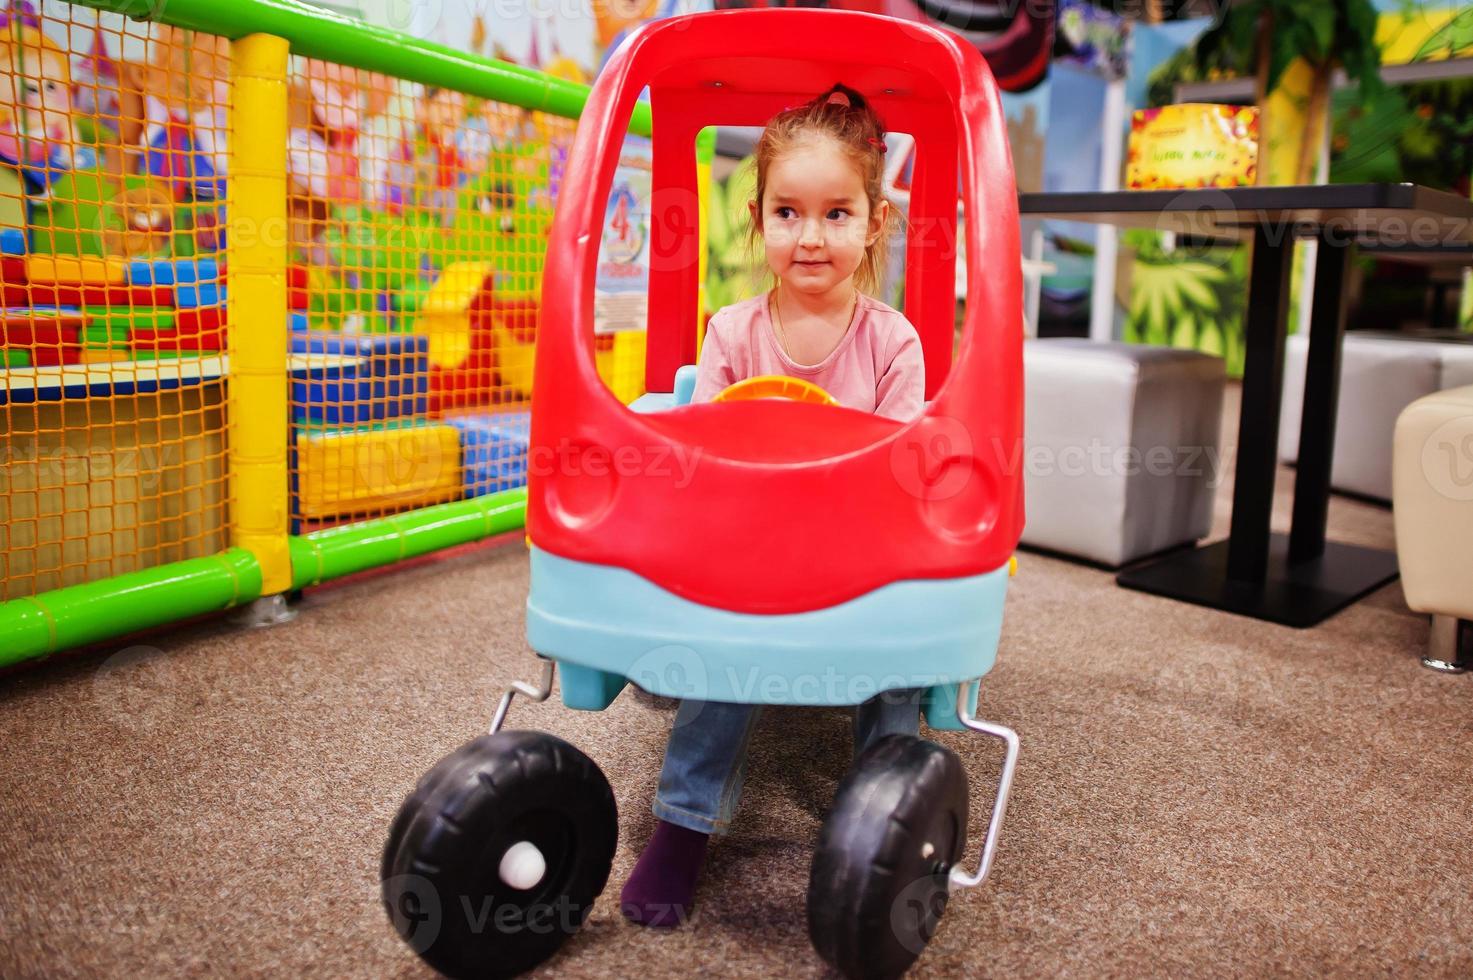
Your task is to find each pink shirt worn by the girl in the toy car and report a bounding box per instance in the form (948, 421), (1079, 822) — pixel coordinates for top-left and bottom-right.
(691, 293), (925, 421)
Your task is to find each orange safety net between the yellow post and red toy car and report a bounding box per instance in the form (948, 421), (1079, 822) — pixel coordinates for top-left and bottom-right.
(287, 57), (644, 532)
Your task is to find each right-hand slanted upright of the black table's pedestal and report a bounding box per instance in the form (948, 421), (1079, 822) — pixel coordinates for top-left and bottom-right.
(1289, 236), (1351, 561)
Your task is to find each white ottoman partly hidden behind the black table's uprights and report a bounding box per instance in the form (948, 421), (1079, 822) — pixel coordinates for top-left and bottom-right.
(1279, 333), (1473, 500)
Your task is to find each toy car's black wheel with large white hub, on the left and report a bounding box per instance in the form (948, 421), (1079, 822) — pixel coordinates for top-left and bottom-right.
(380, 731), (619, 977)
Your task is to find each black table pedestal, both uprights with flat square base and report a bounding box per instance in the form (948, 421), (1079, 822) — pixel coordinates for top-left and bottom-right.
(1117, 230), (1396, 628)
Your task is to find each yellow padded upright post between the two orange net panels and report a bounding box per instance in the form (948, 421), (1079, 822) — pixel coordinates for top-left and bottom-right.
(225, 34), (292, 595)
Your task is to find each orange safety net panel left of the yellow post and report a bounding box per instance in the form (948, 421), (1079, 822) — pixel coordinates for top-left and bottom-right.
(0, 3), (230, 600)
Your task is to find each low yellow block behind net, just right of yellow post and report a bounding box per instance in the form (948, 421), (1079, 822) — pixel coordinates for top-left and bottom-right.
(296, 424), (461, 519)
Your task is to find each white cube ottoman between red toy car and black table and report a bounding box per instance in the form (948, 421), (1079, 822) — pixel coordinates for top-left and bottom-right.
(1022, 339), (1224, 567)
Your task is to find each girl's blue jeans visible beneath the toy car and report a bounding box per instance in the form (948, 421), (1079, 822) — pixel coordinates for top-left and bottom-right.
(654, 688), (925, 834)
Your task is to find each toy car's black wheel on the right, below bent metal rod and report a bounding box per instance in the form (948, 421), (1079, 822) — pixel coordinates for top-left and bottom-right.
(809, 735), (966, 980)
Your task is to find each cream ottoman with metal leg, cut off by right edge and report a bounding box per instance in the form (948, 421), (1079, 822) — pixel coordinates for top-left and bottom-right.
(1392, 386), (1473, 669)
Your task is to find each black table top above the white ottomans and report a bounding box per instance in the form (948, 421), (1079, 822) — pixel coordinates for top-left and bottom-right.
(1018, 184), (1473, 249)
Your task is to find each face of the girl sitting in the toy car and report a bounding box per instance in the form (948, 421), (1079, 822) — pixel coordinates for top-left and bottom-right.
(750, 139), (890, 296)
